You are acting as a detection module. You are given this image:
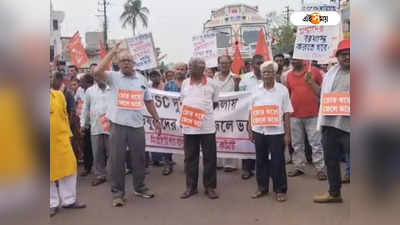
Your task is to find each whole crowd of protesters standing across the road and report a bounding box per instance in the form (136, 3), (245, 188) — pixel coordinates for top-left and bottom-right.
(50, 40), (350, 216)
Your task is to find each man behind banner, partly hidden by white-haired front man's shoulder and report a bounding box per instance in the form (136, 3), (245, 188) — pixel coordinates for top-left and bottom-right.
(235, 55), (264, 180)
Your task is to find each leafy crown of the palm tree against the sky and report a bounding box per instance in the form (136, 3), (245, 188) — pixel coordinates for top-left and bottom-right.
(120, 0), (149, 36)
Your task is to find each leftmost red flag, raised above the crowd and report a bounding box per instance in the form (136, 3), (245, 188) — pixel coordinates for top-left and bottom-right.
(68, 31), (89, 68)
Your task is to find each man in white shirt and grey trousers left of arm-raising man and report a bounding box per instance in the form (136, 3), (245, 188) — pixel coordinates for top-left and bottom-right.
(81, 76), (110, 186)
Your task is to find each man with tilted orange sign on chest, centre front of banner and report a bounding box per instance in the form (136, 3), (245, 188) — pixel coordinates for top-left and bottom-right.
(179, 58), (219, 199)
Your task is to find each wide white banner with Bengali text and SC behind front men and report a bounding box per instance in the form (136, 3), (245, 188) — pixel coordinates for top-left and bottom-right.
(143, 89), (255, 159)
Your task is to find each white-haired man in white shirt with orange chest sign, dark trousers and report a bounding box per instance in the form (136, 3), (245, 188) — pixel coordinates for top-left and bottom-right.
(248, 61), (293, 202)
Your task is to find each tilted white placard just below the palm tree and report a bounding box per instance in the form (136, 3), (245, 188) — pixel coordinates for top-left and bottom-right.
(126, 33), (158, 70)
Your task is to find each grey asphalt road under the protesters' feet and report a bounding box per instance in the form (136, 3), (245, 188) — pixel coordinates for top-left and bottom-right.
(50, 155), (350, 225)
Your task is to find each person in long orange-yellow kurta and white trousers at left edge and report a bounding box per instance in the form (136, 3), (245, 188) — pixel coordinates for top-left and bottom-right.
(50, 73), (86, 216)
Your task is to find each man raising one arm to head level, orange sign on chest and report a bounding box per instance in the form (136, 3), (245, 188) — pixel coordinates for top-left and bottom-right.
(94, 42), (161, 207)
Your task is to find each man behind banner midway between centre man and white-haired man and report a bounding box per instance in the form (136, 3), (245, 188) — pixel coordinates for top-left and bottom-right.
(214, 55), (239, 172)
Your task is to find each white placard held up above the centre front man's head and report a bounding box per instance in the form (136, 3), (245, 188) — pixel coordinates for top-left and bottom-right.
(192, 33), (218, 67)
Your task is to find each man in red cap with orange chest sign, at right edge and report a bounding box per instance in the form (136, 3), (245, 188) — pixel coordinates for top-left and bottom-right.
(314, 40), (350, 203)
